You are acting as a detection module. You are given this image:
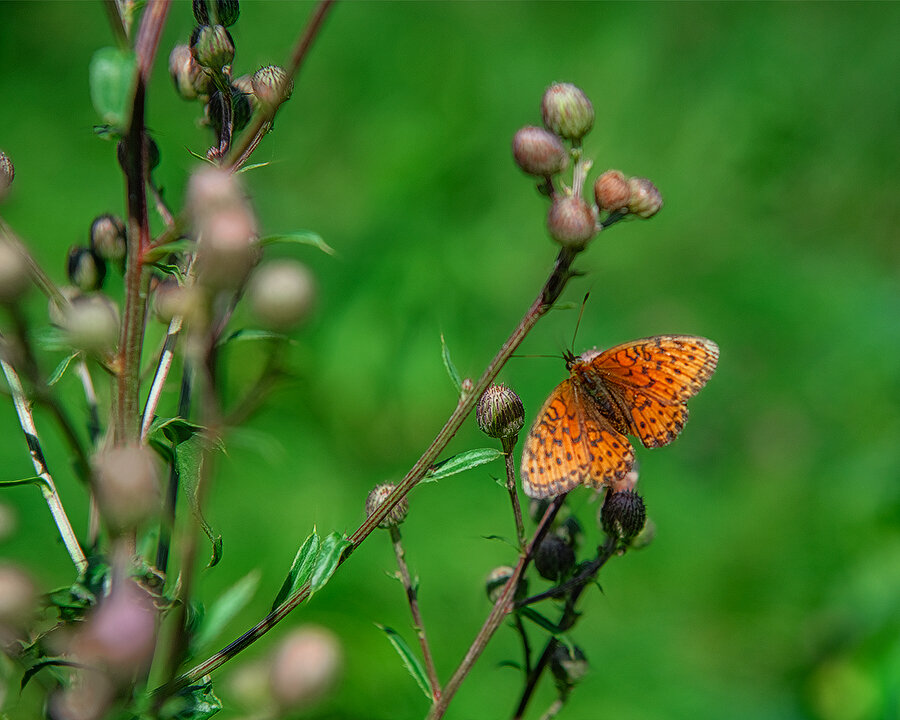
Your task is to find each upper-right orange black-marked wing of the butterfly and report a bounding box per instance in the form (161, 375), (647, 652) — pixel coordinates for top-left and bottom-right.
(584, 335), (719, 447)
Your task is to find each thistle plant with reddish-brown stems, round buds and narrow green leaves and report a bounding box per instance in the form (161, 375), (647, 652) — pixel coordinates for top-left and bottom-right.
(0, 0), (716, 720)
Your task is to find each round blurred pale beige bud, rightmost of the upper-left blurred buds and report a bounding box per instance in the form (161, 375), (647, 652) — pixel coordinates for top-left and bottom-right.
(248, 260), (316, 330)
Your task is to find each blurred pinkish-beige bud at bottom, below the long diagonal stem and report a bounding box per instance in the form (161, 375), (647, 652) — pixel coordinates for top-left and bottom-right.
(271, 625), (343, 709)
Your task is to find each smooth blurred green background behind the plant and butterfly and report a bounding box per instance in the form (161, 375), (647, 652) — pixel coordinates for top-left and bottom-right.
(0, 2), (900, 720)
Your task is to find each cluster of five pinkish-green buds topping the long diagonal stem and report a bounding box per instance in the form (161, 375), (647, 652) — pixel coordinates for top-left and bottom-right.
(513, 83), (662, 252)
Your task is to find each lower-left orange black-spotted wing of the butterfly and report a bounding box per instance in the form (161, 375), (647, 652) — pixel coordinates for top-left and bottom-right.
(522, 378), (634, 498)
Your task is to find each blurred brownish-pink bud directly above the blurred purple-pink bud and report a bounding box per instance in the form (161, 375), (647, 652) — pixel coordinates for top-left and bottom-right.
(93, 445), (160, 531)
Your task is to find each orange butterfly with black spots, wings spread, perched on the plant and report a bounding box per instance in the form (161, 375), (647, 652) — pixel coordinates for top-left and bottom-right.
(522, 335), (719, 498)
